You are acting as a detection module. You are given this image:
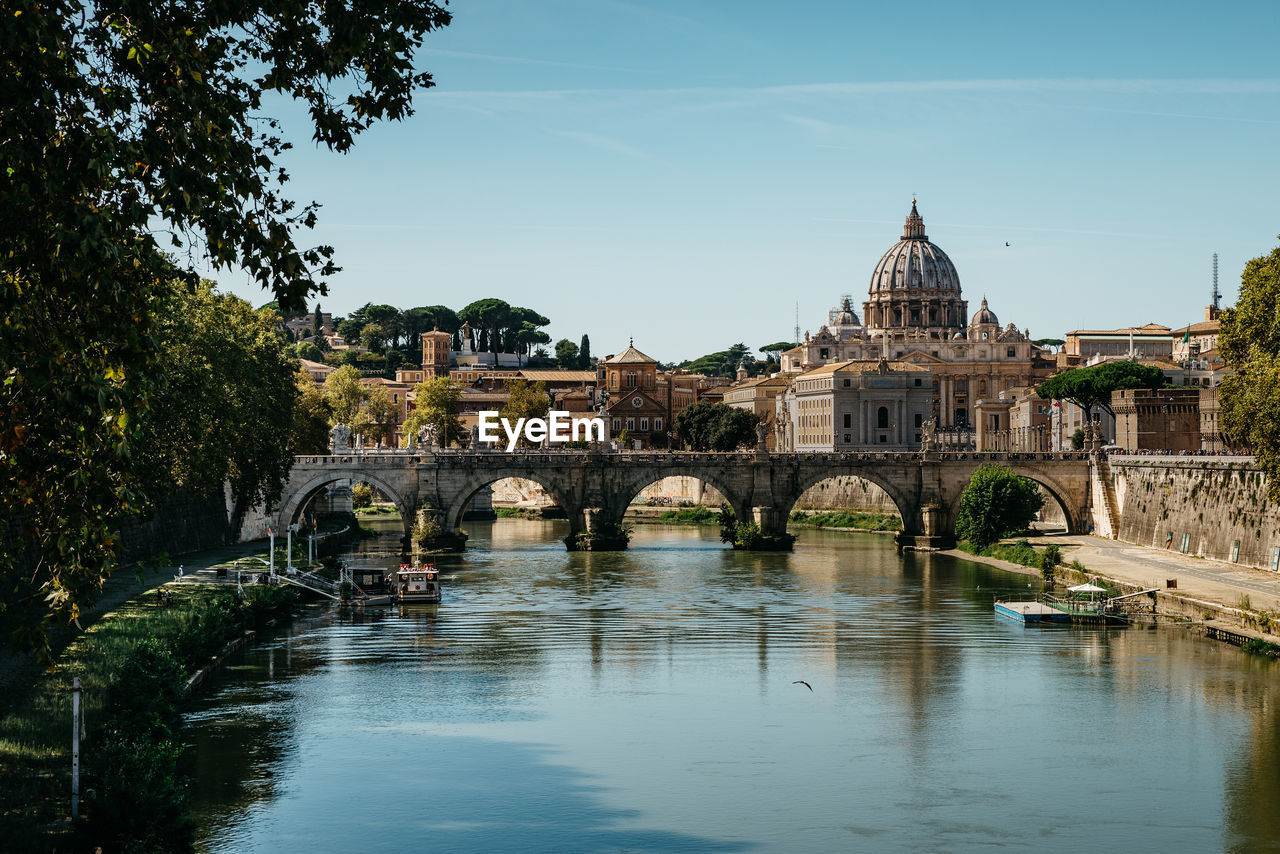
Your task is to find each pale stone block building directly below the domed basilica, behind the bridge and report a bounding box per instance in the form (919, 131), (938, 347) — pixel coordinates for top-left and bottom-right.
(774, 359), (933, 451)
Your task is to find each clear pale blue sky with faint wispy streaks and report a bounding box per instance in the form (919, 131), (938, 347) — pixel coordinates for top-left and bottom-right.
(209, 0), (1280, 361)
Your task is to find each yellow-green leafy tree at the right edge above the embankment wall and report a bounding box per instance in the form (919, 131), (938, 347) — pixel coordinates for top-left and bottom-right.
(1217, 240), (1280, 501)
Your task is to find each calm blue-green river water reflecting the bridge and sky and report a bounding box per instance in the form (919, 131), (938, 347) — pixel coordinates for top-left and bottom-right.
(189, 520), (1280, 854)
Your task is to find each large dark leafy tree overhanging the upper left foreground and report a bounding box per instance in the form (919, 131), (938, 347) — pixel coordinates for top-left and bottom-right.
(0, 0), (449, 650)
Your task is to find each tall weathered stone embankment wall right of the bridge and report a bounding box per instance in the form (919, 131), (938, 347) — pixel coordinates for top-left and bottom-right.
(1110, 457), (1280, 570)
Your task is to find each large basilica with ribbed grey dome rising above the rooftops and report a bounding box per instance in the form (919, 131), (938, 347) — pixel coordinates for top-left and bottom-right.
(782, 200), (1055, 429)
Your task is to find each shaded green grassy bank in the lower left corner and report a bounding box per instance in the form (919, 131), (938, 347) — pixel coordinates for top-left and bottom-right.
(0, 585), (297, 851)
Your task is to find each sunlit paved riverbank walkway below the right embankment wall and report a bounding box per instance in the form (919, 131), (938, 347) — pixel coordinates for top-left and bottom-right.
(942, 534), (1280, 645)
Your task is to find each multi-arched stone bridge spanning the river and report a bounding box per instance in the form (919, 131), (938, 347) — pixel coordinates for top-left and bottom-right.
(270, 451), (1091, 548)
